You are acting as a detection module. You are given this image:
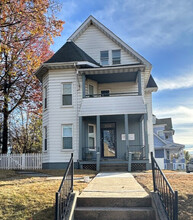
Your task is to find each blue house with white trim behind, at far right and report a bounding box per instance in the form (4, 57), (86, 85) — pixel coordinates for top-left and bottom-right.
(153, 116), (185, 170)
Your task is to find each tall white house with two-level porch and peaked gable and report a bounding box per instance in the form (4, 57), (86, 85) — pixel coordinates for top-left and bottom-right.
(36, 16), (157, 169)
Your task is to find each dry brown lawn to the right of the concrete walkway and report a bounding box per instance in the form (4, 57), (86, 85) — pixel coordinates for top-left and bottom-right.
(135, 171), (193, 220)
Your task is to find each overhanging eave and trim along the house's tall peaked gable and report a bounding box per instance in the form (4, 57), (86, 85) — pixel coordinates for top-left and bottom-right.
(68, 15), (151, 68)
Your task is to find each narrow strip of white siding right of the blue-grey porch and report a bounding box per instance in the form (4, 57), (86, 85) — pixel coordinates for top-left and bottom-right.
(144, 93), (154, 158)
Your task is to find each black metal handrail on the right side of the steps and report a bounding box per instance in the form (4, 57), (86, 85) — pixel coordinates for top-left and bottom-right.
(151, 152), (178, 220)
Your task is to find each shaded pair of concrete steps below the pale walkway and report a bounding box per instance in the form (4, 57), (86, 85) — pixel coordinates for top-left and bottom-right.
(74, 197), (155, 220)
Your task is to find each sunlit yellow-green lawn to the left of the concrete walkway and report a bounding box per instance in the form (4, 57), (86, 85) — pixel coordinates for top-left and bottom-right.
(0, 170), (96, 220)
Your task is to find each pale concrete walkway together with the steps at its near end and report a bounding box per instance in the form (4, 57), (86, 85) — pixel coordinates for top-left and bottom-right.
(74, 172), (156, 220)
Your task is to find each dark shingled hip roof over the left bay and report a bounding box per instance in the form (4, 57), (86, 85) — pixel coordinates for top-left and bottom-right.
(45, 42), (100, 66)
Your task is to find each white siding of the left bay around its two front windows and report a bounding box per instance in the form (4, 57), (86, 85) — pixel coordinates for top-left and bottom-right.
(48, 70), (82, 162)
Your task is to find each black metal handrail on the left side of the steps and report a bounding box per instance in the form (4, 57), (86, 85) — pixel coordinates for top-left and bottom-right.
(55, 154), (74, 220)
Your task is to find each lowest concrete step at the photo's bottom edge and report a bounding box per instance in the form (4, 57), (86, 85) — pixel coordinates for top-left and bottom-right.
(74, 207), (155, 220)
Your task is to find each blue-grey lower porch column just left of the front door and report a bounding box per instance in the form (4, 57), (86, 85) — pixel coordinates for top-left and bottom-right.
(96, 115), (101, 171)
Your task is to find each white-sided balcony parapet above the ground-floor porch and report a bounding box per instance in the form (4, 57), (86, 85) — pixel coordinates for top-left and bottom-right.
(79, 96), (147, 116)
